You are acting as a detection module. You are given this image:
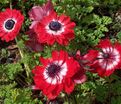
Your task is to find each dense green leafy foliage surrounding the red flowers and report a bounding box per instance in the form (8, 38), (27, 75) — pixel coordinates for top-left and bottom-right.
(0, 0), (121, 104)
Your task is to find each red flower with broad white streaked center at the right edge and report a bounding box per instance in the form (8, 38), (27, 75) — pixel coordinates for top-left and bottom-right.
(84, 39), (121, 76)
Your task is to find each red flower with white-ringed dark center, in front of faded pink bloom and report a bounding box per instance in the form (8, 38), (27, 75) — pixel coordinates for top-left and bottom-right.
(35, 12), (75, 45)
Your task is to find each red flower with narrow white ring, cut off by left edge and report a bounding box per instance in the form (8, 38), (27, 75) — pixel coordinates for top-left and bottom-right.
(0, 9), (24, 42)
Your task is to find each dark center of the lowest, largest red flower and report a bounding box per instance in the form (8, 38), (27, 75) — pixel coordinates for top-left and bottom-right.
(47, 64), (61, 77)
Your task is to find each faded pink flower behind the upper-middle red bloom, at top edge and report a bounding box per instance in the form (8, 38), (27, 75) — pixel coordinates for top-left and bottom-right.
(28, 0), (54, 29)
